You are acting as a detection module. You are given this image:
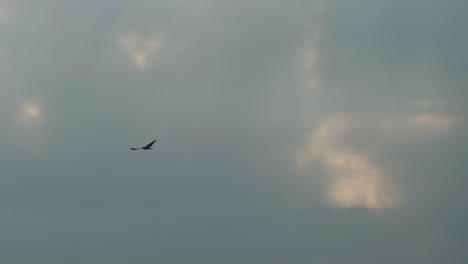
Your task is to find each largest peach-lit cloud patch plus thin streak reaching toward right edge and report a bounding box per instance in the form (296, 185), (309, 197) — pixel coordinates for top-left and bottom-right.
(295, 106), (457, 208)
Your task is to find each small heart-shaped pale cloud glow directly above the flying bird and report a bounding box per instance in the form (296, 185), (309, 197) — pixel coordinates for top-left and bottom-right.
(118, 33), (162, 70)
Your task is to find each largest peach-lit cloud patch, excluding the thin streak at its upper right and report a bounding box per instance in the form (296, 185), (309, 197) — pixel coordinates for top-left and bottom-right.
(297, 118), (396, 208)
